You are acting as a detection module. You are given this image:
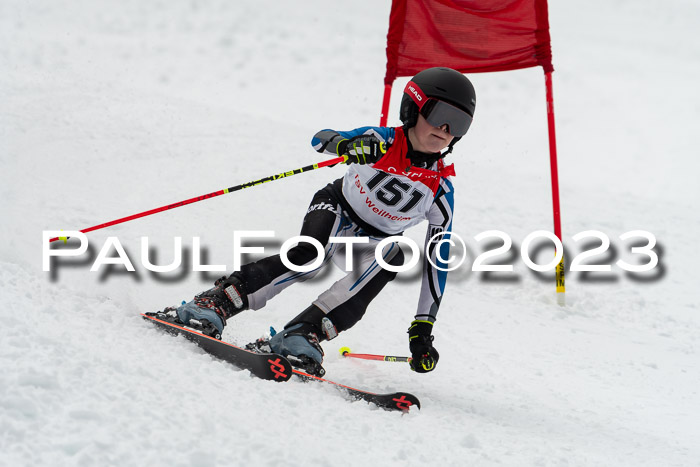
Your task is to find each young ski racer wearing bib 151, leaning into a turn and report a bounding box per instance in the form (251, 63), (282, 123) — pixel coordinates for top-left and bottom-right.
(164, 68), (476, 375)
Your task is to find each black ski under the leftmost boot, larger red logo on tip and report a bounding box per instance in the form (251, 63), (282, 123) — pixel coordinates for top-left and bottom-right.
(141, 313), (292, 382)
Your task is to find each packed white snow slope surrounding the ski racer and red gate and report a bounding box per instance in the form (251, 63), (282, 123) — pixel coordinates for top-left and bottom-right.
(0, 0), (700, 466)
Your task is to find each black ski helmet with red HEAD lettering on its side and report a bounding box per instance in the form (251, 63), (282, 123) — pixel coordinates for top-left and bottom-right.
(399, 67), (476, 144)
